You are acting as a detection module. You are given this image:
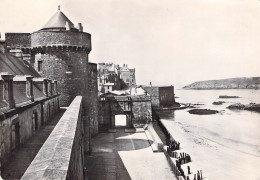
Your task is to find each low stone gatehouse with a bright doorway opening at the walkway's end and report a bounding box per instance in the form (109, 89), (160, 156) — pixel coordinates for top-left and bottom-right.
(99, 88), (152, 130)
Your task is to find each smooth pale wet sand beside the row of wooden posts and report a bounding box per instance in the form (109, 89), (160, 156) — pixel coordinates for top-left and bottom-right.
(161, 119), (260, 180)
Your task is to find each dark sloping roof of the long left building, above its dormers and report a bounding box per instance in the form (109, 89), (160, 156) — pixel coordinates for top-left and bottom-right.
(0, 53), (40, 77)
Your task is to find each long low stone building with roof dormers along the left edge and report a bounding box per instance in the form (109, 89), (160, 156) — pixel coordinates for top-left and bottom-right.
(0, 42), (59, 173)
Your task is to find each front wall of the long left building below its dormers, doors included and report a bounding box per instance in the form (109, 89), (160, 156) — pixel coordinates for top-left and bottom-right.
(0, 95), (59, 168)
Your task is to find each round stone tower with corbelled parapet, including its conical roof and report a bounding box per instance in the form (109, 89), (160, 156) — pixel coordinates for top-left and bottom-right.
(31, 8), (91, 106)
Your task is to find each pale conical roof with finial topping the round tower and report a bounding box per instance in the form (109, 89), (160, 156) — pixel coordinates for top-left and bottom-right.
(41, 7), (75, 30)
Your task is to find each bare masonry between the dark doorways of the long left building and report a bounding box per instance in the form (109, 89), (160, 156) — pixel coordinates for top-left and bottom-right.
(0, 97), (59, 167)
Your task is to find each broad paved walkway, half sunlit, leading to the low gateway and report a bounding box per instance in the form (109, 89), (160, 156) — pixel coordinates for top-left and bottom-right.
(85, 129), (176, 180)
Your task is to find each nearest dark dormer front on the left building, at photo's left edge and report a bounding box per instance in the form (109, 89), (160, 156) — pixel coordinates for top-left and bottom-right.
(1, 74), (15, 109)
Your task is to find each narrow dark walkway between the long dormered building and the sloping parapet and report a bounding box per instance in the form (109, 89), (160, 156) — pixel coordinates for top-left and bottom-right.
(1, 109), (65, 180)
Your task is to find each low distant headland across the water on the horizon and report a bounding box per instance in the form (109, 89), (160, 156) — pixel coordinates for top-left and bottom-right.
(183, 77), (260, 89)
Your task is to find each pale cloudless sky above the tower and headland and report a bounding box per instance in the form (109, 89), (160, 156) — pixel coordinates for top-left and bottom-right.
(0, 0), (260, 87)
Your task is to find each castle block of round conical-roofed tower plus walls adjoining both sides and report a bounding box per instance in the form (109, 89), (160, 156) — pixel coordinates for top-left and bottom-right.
(5, 7), (98, 150)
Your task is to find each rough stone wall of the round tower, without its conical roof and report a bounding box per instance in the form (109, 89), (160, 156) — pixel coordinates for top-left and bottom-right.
(31, 31), (91, 153)
